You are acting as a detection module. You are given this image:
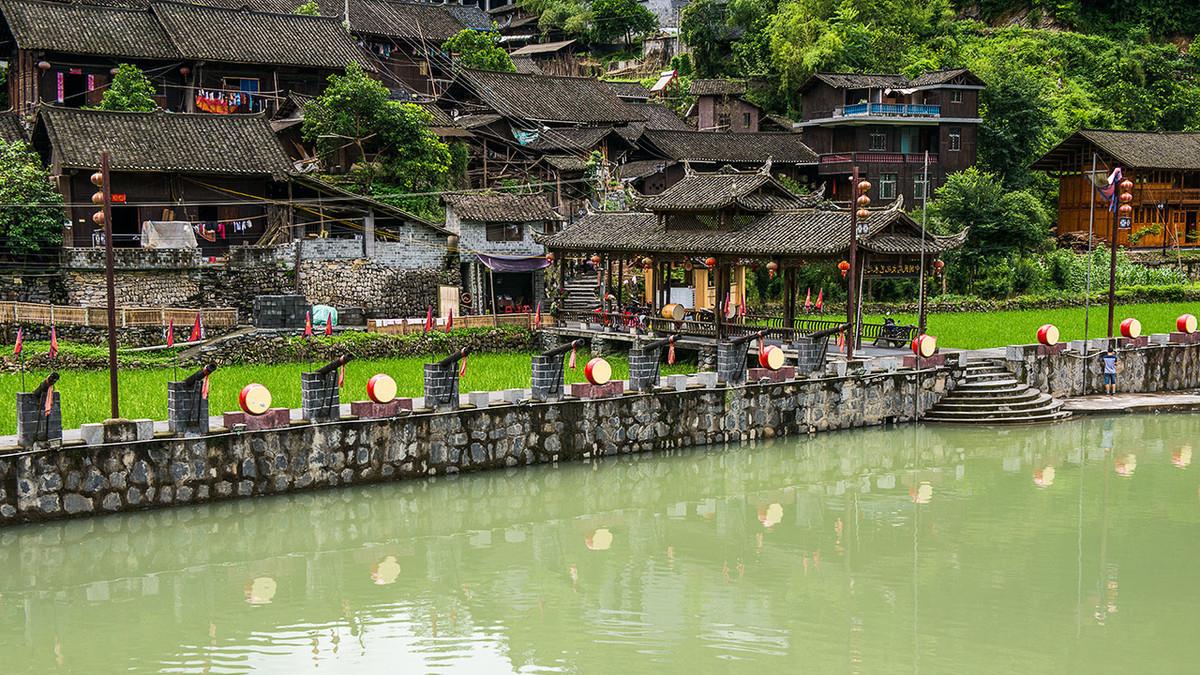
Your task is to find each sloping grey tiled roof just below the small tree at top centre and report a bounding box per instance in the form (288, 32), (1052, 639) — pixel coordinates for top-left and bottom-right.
(460, 68), (644, 124)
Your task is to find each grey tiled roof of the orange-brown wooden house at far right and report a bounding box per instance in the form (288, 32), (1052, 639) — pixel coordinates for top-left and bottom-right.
(1031, 129), (1200, 172)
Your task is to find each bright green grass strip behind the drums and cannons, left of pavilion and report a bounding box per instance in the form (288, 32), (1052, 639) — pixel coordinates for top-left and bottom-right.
(0, 352), (695, 435)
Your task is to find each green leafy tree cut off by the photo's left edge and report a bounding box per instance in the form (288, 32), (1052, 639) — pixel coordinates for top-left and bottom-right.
(0, 141), (64, 256)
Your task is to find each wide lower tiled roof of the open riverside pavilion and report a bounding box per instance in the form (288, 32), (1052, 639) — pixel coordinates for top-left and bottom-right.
(536, 195), (966, 258)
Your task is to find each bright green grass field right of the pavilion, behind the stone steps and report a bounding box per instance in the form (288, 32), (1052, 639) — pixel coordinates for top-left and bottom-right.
(869, 303), (1200, 350)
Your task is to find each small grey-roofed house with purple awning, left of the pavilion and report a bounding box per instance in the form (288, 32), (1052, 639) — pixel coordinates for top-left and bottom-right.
(443, 192), (563, 313)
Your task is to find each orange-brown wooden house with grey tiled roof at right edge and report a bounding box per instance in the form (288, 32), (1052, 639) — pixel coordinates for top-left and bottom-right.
(1032, 129), (1200, 247)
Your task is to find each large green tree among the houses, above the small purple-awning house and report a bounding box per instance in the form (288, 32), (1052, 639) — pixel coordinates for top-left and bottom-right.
(301, 64), (451, 215)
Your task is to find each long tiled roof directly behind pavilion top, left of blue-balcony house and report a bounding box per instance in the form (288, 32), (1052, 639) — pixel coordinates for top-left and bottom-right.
(642, 130), (817, 165)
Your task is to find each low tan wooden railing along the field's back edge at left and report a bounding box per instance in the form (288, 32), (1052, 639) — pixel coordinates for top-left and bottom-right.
(0, 303), (238, 328)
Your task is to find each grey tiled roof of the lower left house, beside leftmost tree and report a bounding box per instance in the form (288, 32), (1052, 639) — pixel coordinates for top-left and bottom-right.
(35, 106), (292, 177)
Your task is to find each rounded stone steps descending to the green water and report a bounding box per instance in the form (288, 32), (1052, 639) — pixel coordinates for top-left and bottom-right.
(924, 359), (1070, 424)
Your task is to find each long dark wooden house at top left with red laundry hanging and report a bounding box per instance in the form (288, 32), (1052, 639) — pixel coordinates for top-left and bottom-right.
(0, 0), (374, 114)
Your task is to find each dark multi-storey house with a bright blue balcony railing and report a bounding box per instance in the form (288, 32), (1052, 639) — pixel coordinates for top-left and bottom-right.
(797, 68), (983, 201)
